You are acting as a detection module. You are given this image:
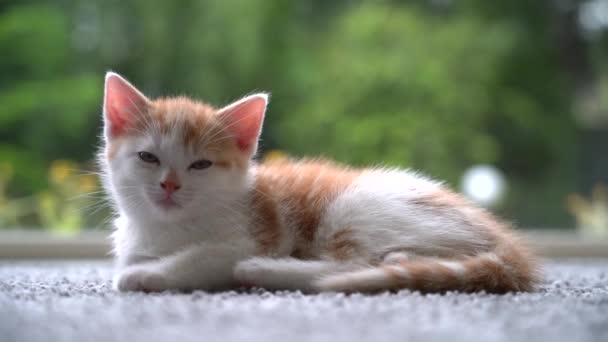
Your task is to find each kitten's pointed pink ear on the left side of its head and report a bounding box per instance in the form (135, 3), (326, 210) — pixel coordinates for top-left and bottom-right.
(103, 72), (150, 139)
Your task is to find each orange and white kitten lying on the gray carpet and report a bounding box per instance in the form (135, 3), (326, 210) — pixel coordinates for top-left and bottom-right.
(100, 73), (537, 293)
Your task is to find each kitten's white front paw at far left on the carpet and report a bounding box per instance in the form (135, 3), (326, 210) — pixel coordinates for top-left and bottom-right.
(114, 268), (168, 292)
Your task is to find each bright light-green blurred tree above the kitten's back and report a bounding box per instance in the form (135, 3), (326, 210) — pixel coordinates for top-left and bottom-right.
(276, 5), (514, 181)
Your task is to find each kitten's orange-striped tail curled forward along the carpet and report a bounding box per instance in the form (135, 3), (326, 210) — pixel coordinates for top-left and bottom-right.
(315, 243), (538, 293)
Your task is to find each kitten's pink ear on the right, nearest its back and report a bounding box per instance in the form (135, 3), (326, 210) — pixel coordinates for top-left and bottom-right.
(218, 93), (268, 155)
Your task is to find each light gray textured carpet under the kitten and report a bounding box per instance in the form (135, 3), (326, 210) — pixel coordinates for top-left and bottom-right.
(0, 260), (608, 342)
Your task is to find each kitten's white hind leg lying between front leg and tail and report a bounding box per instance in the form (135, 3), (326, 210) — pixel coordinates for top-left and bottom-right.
(234, 257), (364, 292)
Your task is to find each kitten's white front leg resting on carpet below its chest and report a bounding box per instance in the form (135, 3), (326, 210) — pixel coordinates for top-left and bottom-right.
(114, 239), (254, 292)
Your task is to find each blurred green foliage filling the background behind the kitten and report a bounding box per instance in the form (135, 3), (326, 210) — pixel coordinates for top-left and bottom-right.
(0, 0), (606, 231)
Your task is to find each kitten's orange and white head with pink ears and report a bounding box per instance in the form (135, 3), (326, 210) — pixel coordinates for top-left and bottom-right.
(101, 73), (268, 219)
